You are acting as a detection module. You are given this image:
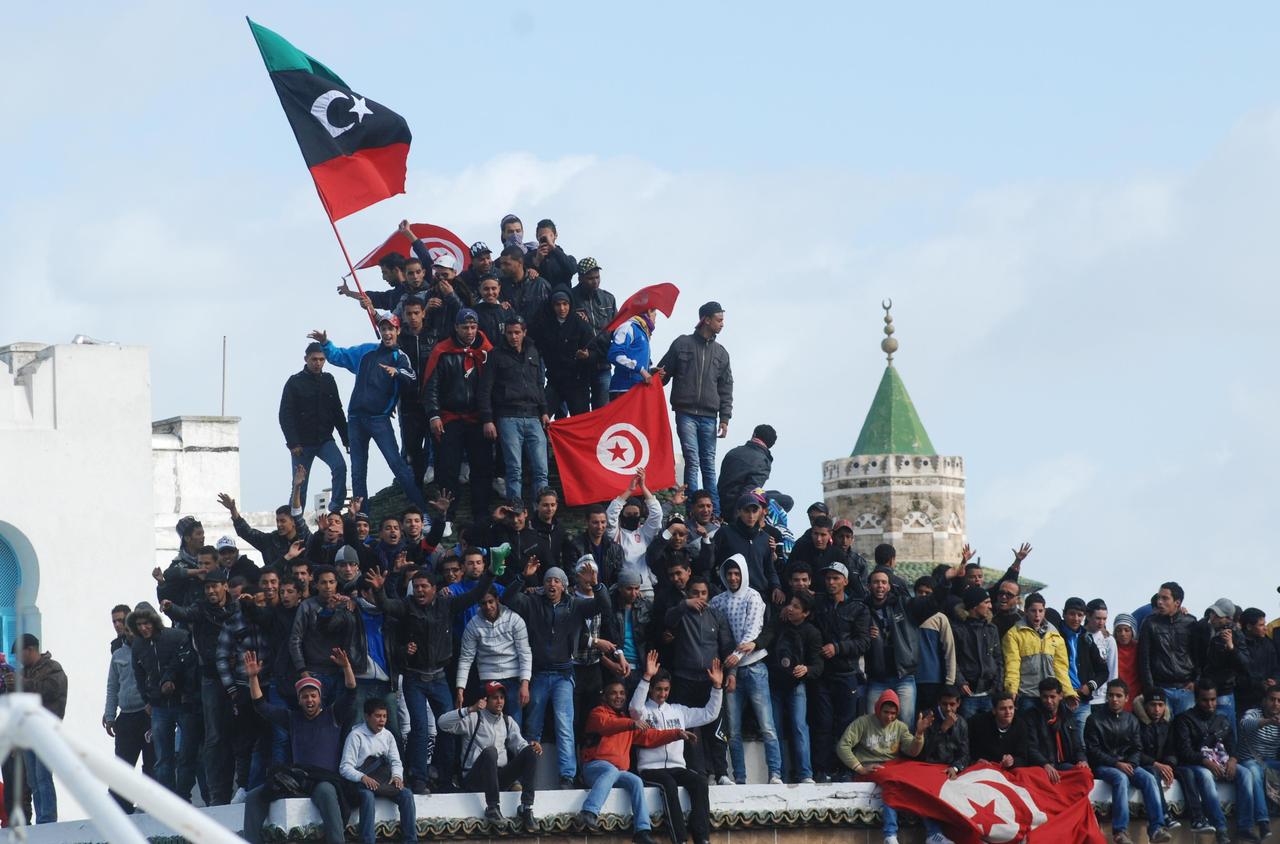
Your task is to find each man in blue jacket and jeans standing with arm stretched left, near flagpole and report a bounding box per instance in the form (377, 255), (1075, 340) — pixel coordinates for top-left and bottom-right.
(308, 314), (426, 510)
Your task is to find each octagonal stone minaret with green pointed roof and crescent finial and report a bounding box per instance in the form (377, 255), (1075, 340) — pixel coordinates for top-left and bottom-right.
(822, 301), (965, 564)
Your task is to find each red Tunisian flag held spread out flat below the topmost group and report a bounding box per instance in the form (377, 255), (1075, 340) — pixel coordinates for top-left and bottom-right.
(550, 378), (676, 507)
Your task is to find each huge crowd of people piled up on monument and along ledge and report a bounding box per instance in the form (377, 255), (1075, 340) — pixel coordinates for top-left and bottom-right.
(6, 215), (1280, 844)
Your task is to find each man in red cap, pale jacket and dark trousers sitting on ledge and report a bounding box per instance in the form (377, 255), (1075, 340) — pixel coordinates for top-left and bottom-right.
(440, 681), (543, 832)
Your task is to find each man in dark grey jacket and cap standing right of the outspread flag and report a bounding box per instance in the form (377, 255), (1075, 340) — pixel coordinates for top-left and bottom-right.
(658, 302), (733, 512)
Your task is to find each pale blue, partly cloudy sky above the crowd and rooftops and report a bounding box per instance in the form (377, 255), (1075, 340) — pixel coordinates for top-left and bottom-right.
(0, 1), (1280, 613)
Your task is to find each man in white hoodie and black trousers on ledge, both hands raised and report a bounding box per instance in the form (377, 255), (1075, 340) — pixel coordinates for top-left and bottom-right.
(631, 653), (726, 844)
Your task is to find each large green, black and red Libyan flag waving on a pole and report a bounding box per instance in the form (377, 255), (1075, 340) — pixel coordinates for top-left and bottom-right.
(248, 20), (412, 220)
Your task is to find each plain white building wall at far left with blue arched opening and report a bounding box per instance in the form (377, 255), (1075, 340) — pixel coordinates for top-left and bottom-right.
(0, 345), (155, 817)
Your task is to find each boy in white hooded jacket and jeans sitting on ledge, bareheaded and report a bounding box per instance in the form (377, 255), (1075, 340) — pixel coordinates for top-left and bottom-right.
(338, 698), (417, 844)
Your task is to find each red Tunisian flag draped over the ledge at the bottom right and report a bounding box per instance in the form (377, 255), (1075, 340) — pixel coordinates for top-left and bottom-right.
(870, 761), (1106, 844)
